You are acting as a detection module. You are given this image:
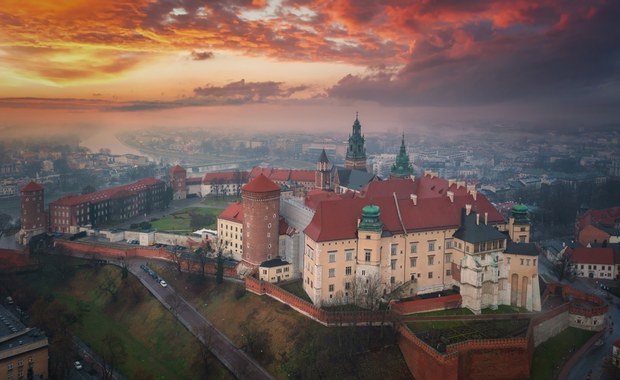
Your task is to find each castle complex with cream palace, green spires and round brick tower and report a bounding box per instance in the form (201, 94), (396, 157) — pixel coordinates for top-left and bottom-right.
(218, 117), (541, 313)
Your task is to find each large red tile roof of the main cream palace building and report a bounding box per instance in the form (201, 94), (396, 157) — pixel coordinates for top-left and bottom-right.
(304, 177), (504, 241)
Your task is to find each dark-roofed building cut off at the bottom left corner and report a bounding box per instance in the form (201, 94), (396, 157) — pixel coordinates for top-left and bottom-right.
(0, 305), (49, 380)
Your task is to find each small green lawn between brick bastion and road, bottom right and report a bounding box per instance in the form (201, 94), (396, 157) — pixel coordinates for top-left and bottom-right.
(530, 327), (595, 380)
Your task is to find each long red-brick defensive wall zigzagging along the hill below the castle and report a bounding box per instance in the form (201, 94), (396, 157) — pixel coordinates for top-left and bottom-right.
(56, 240), (607, 379)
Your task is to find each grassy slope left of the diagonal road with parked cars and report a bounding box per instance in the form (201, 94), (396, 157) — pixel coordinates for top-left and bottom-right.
(22, 265), (233, 379)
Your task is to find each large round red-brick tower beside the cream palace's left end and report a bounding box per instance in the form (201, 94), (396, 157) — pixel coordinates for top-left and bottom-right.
(241, 173), (280, 267)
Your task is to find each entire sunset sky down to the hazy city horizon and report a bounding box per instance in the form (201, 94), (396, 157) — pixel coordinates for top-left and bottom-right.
(0, 0), (620, 140)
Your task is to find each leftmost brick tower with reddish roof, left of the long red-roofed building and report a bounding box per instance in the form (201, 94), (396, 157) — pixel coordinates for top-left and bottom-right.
(16, 182), (47, 244)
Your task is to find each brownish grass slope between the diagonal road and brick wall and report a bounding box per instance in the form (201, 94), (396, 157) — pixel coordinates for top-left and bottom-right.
(159, 269), (411, 379)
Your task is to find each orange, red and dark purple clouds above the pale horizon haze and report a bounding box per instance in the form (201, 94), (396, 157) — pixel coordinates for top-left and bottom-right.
(0, 0), (620, 113)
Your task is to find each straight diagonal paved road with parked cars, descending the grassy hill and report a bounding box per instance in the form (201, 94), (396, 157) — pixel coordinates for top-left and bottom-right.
(126, 258), (273, 380)
